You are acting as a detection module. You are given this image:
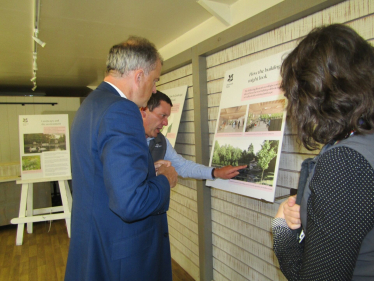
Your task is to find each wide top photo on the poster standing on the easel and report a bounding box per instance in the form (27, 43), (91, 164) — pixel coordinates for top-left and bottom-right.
(23, 133), (66, 154)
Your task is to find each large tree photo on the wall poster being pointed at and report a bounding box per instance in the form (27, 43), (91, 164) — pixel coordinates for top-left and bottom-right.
(211, 138), (279, 186)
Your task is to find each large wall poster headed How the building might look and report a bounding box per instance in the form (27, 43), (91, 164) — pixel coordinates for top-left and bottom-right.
(206, 51), (288, 202)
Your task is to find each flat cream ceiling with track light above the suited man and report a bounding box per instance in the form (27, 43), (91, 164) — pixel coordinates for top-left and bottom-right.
(0, 0), (218, 95)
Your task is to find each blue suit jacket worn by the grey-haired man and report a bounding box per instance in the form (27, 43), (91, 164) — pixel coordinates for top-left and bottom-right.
(65, 82), (172, 281)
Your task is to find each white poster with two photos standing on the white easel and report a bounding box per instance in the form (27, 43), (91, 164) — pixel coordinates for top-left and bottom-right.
(19, 114), (71, 180)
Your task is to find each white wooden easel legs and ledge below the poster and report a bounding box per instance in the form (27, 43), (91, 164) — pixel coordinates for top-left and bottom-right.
(10, 176), (73, 245)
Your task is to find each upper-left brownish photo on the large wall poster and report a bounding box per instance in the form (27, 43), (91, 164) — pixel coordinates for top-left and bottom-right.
(217, 105), (247, 134)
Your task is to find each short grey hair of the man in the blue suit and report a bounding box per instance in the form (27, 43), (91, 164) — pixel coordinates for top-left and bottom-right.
(106, 36), (163, 75)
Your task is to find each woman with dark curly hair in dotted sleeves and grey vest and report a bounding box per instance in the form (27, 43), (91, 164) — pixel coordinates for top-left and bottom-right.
(272, 24), (374, 281)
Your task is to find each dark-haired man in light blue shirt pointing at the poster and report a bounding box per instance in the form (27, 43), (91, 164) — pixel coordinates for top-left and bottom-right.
(141, 91), (246, 179)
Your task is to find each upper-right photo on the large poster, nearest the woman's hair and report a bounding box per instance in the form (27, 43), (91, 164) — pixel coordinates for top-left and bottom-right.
(245, 99), (286, 132)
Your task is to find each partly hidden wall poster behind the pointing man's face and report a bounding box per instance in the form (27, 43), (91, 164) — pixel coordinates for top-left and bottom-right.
(161, 85), (187, 147)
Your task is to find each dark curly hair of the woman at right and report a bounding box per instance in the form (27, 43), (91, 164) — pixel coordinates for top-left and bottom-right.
(281, 24), (374, 150)
